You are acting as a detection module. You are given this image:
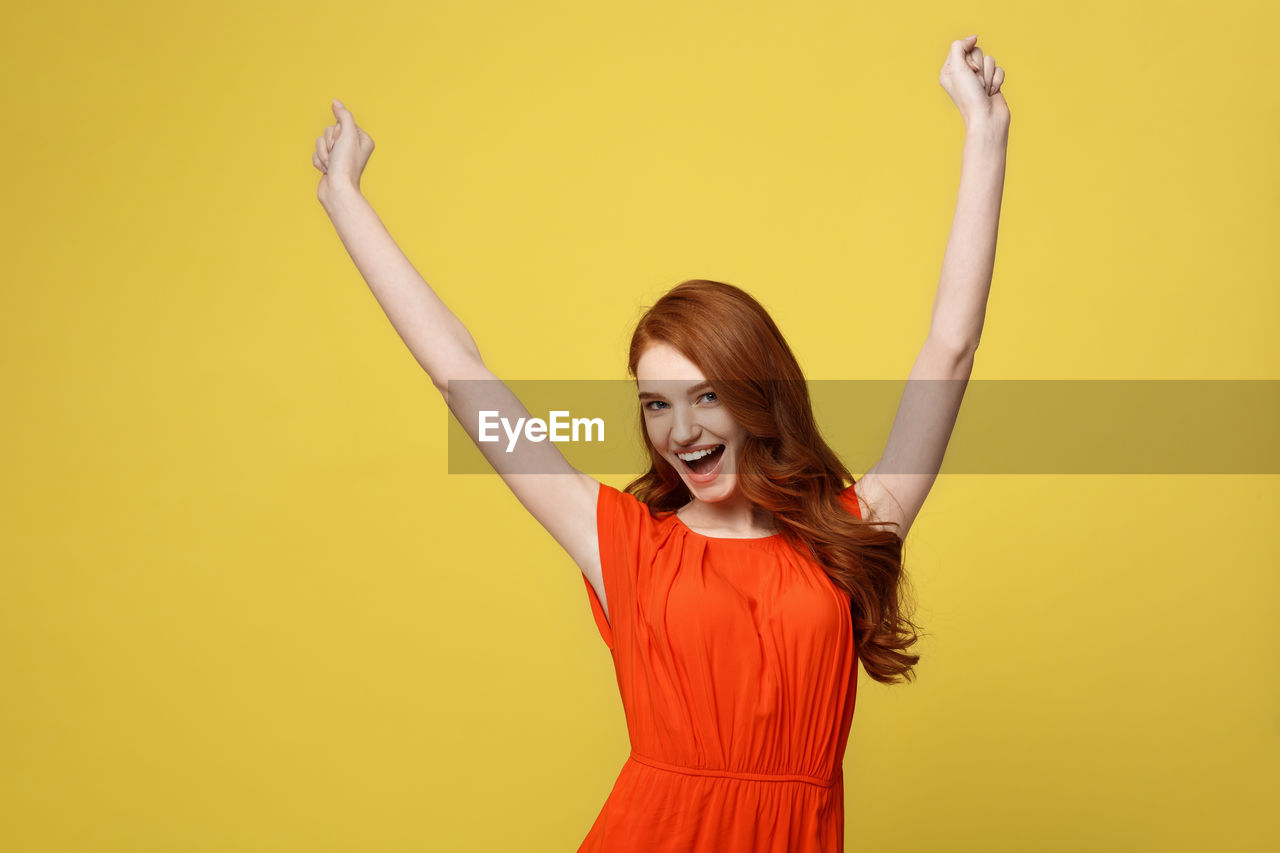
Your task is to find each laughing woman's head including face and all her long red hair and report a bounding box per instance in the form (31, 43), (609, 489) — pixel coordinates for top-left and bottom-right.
(627, 279), (919, 681)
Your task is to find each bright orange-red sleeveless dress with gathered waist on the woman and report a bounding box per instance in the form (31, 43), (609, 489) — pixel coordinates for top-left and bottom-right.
(579, 483), (861, 853)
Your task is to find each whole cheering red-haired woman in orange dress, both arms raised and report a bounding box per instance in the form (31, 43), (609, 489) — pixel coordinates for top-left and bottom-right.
(314, 36), (1009, 853)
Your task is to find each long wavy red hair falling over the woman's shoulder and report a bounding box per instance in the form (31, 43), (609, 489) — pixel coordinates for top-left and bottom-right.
(626, 279), (920, 684)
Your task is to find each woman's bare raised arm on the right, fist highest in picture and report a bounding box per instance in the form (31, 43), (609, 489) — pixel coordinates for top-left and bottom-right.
(855, 36), (1010, 538)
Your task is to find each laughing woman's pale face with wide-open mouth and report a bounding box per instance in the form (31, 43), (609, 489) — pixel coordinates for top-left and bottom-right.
(636, 343), (746, 503)
